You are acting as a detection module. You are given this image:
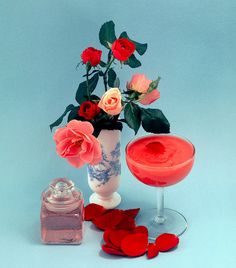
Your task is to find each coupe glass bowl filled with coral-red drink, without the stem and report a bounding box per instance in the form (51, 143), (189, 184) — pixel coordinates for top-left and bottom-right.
(126, 134), (195, 187)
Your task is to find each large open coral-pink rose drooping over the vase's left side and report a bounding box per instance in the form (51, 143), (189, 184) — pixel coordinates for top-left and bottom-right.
(54, 120), (102, 168)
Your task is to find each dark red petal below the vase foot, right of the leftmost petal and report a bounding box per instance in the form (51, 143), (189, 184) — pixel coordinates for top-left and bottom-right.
(93, 209), (122, 230)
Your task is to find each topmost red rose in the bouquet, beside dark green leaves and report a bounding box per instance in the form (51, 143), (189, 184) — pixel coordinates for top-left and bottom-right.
(111, 38), (135, 61)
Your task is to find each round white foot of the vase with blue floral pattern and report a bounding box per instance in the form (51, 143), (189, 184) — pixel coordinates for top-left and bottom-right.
(89, 192), (121, 209)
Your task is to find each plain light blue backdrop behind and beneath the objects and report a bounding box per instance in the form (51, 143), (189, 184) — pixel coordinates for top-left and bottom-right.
(0, 0), (236, 268)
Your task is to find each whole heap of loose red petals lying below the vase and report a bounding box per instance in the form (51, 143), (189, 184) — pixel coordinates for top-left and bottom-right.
(85, 204), (179, 259)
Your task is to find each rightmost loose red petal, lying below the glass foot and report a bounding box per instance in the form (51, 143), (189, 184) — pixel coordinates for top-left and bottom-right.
(156, 233), (179, 252)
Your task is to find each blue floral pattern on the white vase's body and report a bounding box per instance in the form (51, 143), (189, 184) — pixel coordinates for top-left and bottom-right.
(88, 142), (121, 186)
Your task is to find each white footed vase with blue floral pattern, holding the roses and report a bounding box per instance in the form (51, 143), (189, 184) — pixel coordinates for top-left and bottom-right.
(88, 129), (121, 209)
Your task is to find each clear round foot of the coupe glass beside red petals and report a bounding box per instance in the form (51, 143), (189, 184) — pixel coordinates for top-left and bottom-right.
(136, 208), (187, 240)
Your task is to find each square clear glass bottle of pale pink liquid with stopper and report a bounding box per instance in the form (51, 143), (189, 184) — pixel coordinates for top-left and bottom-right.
(40, 178), (84, 244)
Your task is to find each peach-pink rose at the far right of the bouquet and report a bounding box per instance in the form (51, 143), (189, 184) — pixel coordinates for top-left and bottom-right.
(127, 74), (160, 105)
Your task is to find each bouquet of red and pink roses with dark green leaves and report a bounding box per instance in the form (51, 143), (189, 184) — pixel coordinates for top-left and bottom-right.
(50, 21), (170, 167)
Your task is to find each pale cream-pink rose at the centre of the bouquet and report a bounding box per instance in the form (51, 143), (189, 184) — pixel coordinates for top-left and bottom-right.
(98, 88), (122, 115)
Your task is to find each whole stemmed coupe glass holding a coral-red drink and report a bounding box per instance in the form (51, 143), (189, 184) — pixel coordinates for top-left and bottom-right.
(126, 134), (195, 240)
